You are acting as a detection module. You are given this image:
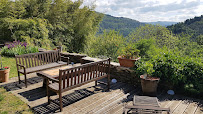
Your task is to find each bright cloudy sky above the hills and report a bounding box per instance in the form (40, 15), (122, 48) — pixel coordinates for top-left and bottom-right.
(80, 0), (203, 22)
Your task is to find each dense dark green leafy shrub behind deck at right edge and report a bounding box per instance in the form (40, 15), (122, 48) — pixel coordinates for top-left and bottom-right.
(134, 51), (203, 97)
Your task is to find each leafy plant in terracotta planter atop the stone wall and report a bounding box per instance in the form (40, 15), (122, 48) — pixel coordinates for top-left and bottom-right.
(118, 45), (140, 67)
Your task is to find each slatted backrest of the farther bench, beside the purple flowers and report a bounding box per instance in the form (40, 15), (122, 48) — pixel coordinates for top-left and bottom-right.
(15, 50), (60, 70)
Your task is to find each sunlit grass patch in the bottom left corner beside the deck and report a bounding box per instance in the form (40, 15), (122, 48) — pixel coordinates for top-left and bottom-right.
(0, 88), (33, 114)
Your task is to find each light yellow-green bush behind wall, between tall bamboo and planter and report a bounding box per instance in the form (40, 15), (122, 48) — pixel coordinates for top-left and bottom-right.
(85, 30), (125, 60)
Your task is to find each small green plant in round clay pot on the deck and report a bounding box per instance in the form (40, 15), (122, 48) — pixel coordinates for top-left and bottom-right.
(140, 62), (160, 96)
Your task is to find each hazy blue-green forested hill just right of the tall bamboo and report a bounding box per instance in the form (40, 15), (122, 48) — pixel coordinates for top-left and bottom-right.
(99, 14), (145, 36)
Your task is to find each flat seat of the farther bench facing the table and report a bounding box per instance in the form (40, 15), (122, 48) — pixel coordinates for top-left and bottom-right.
(19, 61), (67, 74)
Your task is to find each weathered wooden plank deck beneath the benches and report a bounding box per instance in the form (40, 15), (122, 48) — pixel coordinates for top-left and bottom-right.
(0, 74), (203, 114)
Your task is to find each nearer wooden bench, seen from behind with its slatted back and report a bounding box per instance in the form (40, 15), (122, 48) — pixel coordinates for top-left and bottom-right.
(37, 59), (110, 111)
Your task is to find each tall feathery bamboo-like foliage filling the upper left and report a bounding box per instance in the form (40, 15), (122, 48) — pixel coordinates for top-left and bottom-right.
(0, 0), (102, 52)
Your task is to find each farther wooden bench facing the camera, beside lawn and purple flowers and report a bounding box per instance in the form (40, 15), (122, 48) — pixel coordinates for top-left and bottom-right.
(15, 50), (69, 87)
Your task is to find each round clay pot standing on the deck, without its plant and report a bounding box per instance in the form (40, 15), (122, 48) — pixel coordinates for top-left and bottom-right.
(140, 75), (160, 96)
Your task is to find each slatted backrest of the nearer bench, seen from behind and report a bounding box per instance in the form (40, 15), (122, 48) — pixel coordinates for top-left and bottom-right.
(59, 59), (110, 90)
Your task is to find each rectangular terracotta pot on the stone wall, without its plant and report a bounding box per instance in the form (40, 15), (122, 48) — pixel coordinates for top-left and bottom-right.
(118, 56), (140, 67)
